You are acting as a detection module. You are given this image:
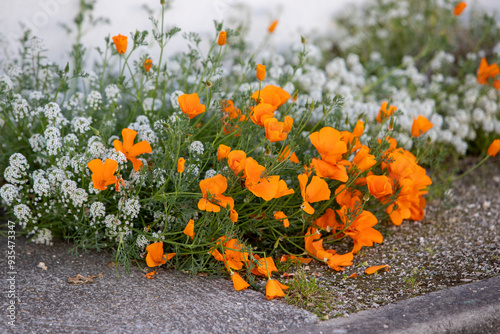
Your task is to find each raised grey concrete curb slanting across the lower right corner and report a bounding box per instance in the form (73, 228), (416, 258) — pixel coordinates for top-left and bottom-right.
(296, 276), (500, 334)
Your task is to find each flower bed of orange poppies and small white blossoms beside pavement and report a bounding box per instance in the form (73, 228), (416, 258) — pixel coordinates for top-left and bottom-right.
(0, 1), (500, 299)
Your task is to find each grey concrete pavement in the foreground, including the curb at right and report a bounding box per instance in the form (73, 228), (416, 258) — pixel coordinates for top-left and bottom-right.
(0, 238), (500, 333)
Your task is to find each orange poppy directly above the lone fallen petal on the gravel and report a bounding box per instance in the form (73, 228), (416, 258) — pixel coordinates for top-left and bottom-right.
(337, 207), (383, 254)
